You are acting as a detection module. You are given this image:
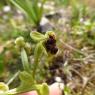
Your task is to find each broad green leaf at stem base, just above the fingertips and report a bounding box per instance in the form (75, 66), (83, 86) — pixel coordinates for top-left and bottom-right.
(17, 71), (35, 92)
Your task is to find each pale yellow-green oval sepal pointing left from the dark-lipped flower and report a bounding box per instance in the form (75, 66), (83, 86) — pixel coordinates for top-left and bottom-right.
(30, 32), (46, 42)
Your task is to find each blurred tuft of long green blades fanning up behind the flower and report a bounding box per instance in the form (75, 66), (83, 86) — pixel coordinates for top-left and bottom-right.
(10, 0), (46, 26)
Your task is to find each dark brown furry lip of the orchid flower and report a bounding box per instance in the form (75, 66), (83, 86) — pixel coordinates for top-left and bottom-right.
(45, 35), (58, 54)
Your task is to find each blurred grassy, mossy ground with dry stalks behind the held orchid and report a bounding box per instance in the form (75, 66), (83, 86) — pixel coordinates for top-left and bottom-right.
(0, 0), (95, 95)
